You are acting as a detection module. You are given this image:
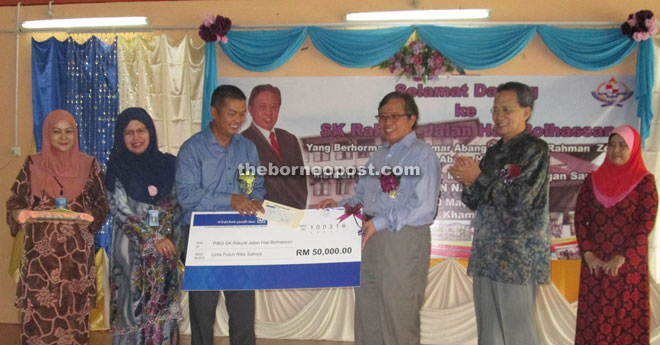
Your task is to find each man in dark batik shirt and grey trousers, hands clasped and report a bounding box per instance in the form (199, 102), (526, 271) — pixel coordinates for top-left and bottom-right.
(449, 82), (550, 345)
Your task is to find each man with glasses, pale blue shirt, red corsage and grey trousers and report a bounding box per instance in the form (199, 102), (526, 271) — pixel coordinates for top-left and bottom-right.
(319, 92), (440, 345)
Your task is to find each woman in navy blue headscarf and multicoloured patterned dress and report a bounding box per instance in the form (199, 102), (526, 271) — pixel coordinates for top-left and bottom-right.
(105, 108), (181, 345)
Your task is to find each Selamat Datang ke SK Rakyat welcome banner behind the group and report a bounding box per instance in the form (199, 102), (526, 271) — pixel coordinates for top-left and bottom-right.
(220, 75), (639, 258)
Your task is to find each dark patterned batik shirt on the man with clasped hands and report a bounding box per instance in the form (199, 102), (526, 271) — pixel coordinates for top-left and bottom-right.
(462, 131), (550, 284)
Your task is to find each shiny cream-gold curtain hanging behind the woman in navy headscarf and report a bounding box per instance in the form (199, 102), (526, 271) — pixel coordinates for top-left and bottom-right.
(117, 35), (204, 155)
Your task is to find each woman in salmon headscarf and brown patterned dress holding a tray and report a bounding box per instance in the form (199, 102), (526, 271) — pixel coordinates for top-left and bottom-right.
(7, 110), (108, 345)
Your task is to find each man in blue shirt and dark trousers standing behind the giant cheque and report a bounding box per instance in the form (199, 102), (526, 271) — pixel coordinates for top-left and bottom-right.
(176, 85), (266, 345)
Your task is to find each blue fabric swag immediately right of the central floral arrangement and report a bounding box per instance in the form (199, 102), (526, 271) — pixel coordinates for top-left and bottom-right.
(417, 25), (535, 70)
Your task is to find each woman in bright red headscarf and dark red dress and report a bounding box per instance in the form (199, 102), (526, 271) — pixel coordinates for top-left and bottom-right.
(575, 125), (658, 345)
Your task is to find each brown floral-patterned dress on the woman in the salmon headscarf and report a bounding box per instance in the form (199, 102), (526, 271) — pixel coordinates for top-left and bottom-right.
(7, 156), (108, 345)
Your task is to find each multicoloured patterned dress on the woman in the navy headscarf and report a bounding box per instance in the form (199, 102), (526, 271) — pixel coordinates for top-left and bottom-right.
(108, 181), (183, 338)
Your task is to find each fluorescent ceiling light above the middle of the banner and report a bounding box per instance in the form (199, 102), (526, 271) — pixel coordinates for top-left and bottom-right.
(346, 9), (490, 21)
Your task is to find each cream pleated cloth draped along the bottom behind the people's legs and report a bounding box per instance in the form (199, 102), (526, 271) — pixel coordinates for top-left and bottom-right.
(174, 259), (660, 345)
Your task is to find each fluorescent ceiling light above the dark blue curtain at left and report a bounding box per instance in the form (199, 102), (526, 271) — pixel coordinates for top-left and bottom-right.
(21, 17), (149, 29)
